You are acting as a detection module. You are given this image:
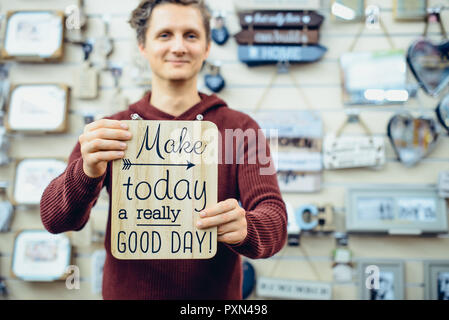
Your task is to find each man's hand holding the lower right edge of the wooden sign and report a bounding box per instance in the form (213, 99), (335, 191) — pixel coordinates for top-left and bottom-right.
(197, 199), (248, 244)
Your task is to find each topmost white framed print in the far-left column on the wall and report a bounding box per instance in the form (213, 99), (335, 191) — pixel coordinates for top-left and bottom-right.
(2, 11), (64, 62)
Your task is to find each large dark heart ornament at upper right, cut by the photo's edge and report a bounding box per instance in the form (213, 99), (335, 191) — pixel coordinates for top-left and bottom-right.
(407, 39), (449, 96)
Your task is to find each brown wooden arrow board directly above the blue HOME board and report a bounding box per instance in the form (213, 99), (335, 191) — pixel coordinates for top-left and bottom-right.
(235, 29), (319, 45)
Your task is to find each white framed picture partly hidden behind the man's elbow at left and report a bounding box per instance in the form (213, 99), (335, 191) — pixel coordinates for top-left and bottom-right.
(12, 158), (67, 205)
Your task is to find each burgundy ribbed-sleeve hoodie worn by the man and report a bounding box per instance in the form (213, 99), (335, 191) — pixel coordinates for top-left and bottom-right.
(40, 93), (287, 300)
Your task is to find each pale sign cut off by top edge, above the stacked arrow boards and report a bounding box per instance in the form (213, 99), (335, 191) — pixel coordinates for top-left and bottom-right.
(233, 0), (321, 11)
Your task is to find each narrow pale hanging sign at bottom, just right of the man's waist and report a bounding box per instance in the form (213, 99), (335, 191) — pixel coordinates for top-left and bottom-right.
(256, 277), (332, 300)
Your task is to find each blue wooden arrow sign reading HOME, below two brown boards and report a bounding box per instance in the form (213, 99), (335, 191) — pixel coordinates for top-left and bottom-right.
(238, 45), (327, 66)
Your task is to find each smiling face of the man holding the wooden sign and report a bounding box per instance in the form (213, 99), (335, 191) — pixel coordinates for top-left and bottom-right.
(139, 4), (210, 81)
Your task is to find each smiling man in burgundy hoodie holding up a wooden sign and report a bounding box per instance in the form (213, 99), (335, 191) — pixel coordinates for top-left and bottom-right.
(41, 0), (287, 299)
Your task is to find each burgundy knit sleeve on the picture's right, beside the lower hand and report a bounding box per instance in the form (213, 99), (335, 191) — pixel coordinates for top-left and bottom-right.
(229, 120), (287, 259)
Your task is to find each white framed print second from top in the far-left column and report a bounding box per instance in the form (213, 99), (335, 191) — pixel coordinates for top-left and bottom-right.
(5, 84), (69, 133)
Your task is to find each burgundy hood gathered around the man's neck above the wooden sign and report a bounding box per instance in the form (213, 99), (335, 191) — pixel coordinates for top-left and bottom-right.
(129, 91), (227, 120)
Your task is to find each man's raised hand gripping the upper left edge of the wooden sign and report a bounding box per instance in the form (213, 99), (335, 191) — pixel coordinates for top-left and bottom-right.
(78, 119), (132, 178)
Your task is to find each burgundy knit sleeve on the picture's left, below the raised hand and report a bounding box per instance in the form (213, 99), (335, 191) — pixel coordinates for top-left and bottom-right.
(40, 143), (108, 233)
